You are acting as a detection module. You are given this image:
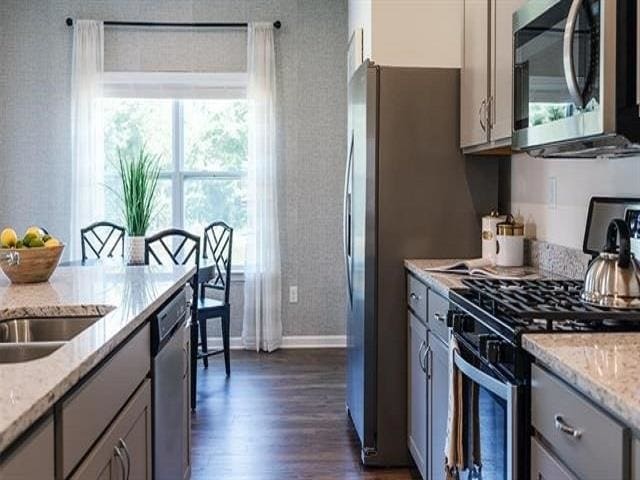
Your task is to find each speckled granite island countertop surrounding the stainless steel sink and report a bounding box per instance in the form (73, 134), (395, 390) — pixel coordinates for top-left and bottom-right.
(0, 265), (195, 451)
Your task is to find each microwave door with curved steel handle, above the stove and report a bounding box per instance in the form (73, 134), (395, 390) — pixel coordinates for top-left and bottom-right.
(512, 0), (604, 150)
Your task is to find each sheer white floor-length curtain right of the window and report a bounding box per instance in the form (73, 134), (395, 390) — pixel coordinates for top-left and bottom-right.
(242, 23), (282, 352)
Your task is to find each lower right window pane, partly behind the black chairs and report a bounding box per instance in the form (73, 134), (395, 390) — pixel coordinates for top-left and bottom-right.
(184, 178), (247, 266)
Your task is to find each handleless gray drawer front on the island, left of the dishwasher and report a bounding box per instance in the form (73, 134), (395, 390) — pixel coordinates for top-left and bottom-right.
(59, 325), (151, 478)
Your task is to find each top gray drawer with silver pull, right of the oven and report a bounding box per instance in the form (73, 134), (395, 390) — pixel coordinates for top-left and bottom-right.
(531, 365), (628, 480)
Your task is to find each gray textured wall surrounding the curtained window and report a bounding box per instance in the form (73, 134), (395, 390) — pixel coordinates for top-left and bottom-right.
(0, 0), (347, 336)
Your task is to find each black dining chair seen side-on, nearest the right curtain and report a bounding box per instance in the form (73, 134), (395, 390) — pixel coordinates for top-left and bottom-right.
(198, 222), (233, 376)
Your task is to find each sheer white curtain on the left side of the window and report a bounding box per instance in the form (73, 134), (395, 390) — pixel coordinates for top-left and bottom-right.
(69, 20), (104, 259)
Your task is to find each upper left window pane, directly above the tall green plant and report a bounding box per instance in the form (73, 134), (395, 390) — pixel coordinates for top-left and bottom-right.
(103, 98), (172, 174)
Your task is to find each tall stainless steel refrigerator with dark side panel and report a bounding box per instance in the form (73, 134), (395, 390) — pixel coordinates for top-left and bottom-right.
(344, 62), (499, 466)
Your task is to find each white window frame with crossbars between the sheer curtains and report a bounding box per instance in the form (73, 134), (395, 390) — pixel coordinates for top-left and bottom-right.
(102, 72), (247, 272)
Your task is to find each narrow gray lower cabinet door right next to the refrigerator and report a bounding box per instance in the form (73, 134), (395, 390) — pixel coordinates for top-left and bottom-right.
(407, 313), (427, 478)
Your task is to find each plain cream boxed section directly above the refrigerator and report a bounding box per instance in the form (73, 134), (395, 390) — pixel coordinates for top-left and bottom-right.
(349, 0), (462, 68)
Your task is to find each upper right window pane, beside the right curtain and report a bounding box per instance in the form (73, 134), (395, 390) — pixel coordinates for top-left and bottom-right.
(183, 100), (247, 172)
